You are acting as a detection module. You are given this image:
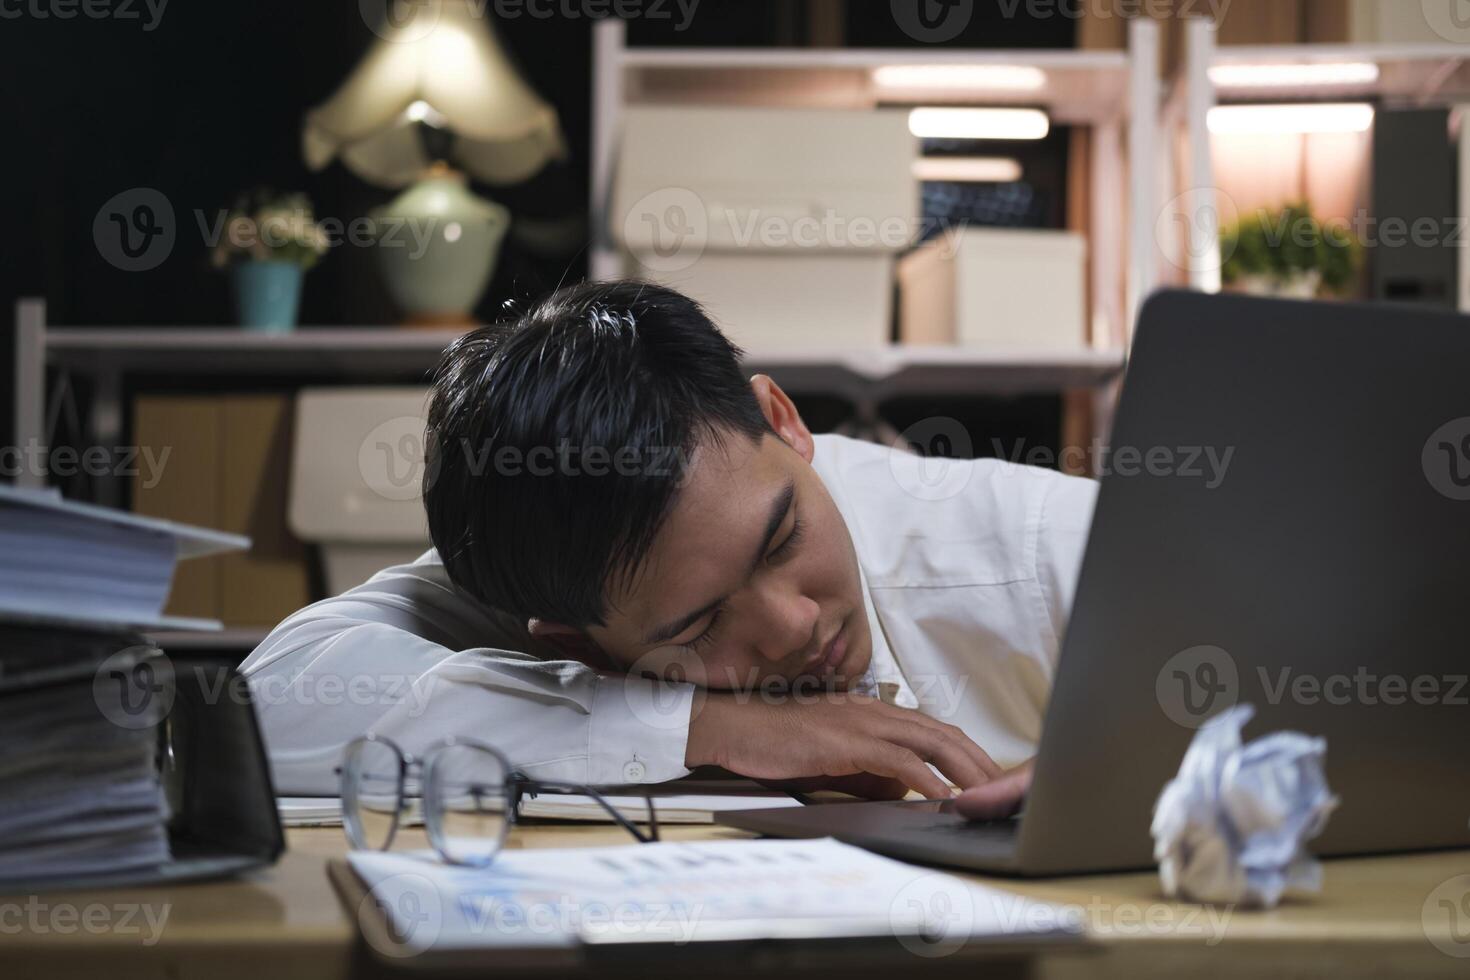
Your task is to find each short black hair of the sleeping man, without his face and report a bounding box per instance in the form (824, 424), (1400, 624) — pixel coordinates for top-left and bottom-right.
(423, 281), (770, 627)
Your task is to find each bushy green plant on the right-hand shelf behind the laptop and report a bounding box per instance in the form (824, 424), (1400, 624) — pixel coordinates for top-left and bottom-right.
(1220, 201), (1360, 300)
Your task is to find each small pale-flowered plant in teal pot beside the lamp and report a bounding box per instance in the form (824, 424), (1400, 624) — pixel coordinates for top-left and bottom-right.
(210, 188), (328, 332)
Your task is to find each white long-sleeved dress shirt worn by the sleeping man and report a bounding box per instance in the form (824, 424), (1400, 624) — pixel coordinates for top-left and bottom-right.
(243, 435), (1095, 795)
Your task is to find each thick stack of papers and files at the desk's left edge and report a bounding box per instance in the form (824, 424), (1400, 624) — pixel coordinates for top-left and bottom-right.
(0, 486), (250, 884)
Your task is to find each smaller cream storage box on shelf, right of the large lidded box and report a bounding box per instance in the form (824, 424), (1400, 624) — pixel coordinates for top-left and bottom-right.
(898, 228), (1086, 351)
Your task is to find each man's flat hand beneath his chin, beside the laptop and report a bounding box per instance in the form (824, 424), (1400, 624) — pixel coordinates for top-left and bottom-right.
(684, 689), (1001, 799)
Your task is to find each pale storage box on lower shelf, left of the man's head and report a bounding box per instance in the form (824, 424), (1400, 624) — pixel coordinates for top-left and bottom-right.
(290, 388), (429, 595)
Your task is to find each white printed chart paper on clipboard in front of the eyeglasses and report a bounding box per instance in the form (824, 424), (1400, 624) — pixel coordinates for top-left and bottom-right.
(348, 837), (1080, 955)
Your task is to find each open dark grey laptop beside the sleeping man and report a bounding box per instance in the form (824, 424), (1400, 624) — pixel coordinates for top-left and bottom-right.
(716, 291), (1470, 876)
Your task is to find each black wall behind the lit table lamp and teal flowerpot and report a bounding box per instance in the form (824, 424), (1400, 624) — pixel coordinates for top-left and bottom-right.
(0, 0), (591, 325)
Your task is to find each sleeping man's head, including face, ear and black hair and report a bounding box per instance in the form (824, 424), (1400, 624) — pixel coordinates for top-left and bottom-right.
(423, 282), (872, 688)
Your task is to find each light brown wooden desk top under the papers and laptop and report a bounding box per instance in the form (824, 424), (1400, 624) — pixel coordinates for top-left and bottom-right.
(0, 824), (1470, 980)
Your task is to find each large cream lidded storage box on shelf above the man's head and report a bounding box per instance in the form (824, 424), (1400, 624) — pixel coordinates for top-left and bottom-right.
(612, 106), (920, 353)
